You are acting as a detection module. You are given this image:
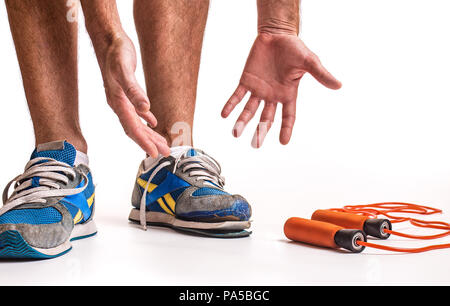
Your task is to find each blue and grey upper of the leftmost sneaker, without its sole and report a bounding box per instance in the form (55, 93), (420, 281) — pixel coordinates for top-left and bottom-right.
(0, 142), (94, 248)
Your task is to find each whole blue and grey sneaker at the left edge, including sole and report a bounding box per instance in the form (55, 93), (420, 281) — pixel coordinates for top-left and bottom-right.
(0, 141), (97, 259)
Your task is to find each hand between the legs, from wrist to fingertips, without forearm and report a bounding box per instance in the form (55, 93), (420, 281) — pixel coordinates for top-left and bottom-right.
(99, 35), (170, 158)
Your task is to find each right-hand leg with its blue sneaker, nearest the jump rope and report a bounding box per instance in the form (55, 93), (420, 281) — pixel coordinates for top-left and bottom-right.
(129, 0), (251, 237)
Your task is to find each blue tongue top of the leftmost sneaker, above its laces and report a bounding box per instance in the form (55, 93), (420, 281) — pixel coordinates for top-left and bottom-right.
(30, 141), (77, 167)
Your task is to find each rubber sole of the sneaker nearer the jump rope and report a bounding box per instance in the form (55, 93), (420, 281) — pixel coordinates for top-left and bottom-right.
(128, 208), (252, 238)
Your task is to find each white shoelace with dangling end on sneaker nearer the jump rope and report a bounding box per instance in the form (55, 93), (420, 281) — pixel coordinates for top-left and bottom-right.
(139, 148), (225, 230)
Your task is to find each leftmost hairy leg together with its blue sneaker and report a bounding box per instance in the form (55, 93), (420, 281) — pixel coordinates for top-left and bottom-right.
(0, 0), (97, 259)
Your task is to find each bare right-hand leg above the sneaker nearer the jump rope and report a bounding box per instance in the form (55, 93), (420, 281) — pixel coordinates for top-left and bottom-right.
(134, 0), (209, 146)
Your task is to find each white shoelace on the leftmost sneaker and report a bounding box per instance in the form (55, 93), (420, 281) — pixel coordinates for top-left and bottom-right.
(0, 157), (88, 216)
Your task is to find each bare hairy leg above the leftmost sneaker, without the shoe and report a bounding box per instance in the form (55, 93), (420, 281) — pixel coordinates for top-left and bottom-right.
(6, 0), (87, 153)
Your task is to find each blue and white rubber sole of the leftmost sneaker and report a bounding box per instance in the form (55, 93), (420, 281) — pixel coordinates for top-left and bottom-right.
(0, 221), (97, 259)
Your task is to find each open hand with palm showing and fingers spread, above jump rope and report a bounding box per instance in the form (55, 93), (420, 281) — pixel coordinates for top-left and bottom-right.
(222, 33), (341, 148)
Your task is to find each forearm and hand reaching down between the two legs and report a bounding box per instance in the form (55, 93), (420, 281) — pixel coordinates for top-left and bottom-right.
(80, 0), (170, 157)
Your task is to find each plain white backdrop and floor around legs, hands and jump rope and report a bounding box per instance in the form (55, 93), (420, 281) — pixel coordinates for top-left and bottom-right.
(0, 0), (450, 285)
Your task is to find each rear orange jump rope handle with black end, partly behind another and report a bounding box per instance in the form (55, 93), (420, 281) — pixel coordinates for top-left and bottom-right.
(311, 209), (392, 239)
